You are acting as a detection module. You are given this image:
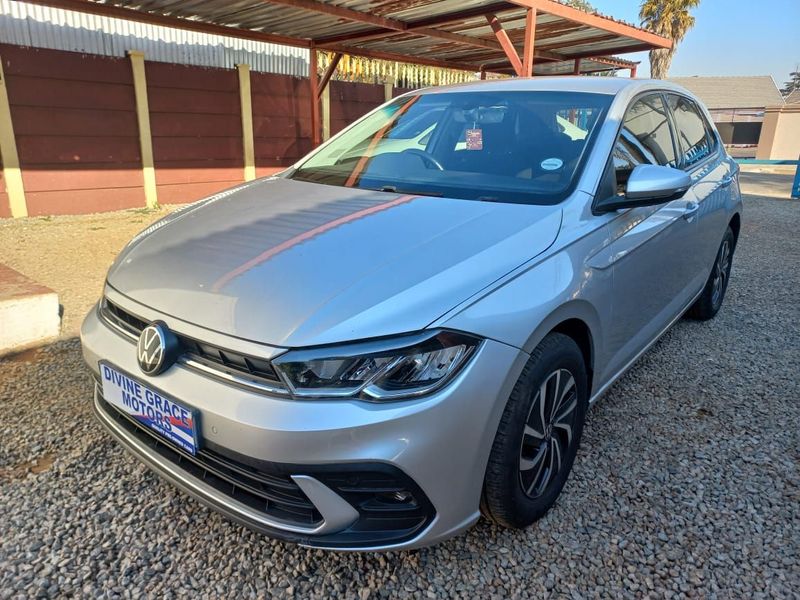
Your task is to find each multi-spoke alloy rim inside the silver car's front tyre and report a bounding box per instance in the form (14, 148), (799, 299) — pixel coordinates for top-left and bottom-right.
(519, 369), (578, 498)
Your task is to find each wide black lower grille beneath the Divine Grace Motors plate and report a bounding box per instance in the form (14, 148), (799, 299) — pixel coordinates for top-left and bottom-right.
(101, 400), (322, 527)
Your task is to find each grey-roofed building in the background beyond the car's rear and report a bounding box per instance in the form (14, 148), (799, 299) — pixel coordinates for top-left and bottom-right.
(669, 75), (784, 158)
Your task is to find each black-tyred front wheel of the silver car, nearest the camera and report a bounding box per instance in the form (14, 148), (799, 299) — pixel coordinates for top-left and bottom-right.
(481, 333), (588, 529)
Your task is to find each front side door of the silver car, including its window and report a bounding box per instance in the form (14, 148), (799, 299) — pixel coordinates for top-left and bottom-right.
(606, 92), (698, 380)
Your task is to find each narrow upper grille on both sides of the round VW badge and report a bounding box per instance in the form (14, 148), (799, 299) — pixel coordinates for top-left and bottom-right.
(100, 298), (284, 388)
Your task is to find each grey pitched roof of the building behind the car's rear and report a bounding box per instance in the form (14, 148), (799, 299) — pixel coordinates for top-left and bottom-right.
(668, 75), (784, 109)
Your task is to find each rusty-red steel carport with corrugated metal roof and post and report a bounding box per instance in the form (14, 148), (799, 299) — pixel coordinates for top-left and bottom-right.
(30, 0), (672, 144)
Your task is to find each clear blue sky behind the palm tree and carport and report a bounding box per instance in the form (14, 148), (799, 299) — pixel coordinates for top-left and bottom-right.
(589, 0), (800, 88)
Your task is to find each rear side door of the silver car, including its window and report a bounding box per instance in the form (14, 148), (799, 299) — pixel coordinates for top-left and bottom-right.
(666, 93), (737, 282)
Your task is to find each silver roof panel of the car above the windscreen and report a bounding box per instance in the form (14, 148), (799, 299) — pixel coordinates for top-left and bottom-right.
(412, 75), (688, 96)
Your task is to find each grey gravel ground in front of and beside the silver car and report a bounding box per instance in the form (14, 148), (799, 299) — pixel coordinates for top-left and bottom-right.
(0, 192), (800, 599)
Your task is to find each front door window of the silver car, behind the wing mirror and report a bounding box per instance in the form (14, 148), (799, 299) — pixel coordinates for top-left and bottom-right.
(614, 94), (677, 187)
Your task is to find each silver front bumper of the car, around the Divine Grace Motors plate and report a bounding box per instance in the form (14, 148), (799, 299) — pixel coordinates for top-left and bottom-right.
(81, 305), (527, 550)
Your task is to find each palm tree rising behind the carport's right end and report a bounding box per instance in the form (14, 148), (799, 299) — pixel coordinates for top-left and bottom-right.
(639, 0), (700, 79)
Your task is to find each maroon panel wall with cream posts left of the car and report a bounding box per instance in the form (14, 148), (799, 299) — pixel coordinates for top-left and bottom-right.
(0, 44), (400, 217)
